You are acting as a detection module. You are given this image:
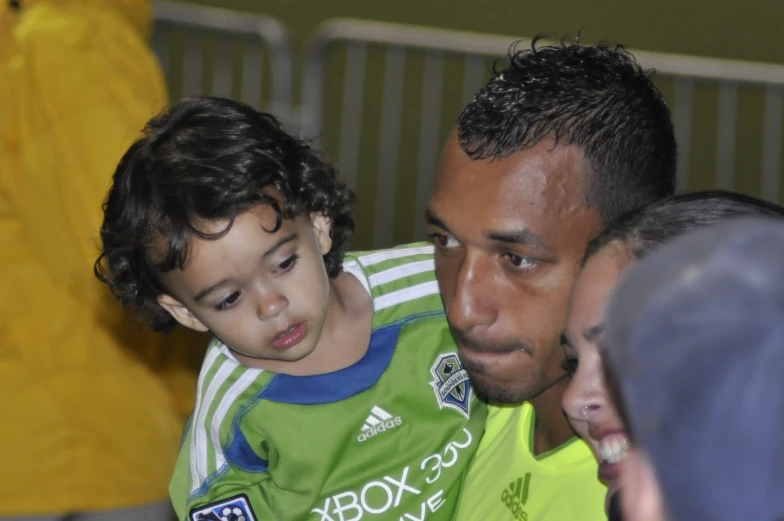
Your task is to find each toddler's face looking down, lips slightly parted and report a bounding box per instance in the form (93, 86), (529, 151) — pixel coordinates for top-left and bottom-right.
(159, 205), (332, 372)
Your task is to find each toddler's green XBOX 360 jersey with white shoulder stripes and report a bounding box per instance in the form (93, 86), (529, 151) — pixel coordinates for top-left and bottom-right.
(170, 244), (486, 521)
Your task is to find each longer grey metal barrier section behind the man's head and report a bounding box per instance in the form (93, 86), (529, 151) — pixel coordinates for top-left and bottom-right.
(301, 19), (784, 246)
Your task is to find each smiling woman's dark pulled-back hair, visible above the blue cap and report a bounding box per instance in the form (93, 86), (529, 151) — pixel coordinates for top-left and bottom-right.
(583, 190), (784, 262)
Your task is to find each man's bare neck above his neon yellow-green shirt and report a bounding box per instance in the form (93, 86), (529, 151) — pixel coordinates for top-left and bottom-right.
(531, 378), (574, 456)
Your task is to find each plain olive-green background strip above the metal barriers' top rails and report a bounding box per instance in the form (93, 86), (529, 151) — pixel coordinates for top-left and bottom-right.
(176, 0), (784, 64)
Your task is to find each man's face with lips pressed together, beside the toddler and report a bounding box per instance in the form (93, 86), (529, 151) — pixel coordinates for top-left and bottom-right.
(427, 134), (599, 403)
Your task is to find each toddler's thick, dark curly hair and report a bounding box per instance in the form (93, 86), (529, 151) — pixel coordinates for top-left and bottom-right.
(95, 96), (354, 331)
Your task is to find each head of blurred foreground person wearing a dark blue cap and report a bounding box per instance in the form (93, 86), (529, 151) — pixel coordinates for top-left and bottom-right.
(604, 218), (784, 521)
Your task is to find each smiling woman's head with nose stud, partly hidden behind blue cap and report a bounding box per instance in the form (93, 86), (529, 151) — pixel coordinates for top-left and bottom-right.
(563, 191), (784, 508)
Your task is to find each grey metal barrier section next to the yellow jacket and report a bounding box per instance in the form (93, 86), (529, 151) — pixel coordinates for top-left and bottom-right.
(153, 1), (293, 125)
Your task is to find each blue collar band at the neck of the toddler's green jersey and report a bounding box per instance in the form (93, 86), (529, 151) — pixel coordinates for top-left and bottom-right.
(260, 324), (402, 405)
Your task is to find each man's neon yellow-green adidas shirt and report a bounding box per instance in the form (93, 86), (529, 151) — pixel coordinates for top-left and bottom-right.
(457, 402), (607, 521)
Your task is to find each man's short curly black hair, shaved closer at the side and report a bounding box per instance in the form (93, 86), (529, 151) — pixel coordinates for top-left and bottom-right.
(457, 35), (677, 223)
